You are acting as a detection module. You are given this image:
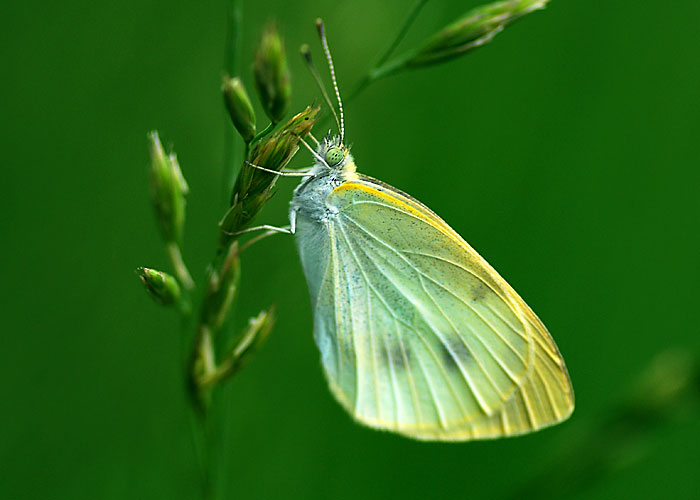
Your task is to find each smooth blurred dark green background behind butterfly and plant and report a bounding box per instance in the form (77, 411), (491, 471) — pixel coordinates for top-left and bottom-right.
(0, 0), (700, 499)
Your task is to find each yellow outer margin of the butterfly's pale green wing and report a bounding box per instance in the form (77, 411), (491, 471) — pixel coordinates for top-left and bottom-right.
(327, 176), (574, 441)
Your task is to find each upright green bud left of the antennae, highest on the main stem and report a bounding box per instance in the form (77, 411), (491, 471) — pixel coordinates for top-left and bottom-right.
(253, 24), (292, 123)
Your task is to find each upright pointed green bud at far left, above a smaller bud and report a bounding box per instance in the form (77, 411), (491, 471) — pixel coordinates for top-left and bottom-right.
(148, 131), (188, 244)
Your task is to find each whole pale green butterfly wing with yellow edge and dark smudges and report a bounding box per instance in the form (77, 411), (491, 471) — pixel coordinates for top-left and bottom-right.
(298, 177), (573, 440)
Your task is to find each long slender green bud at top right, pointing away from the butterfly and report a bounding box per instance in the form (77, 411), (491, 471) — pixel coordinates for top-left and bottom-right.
(406, 0), (549, 67)
